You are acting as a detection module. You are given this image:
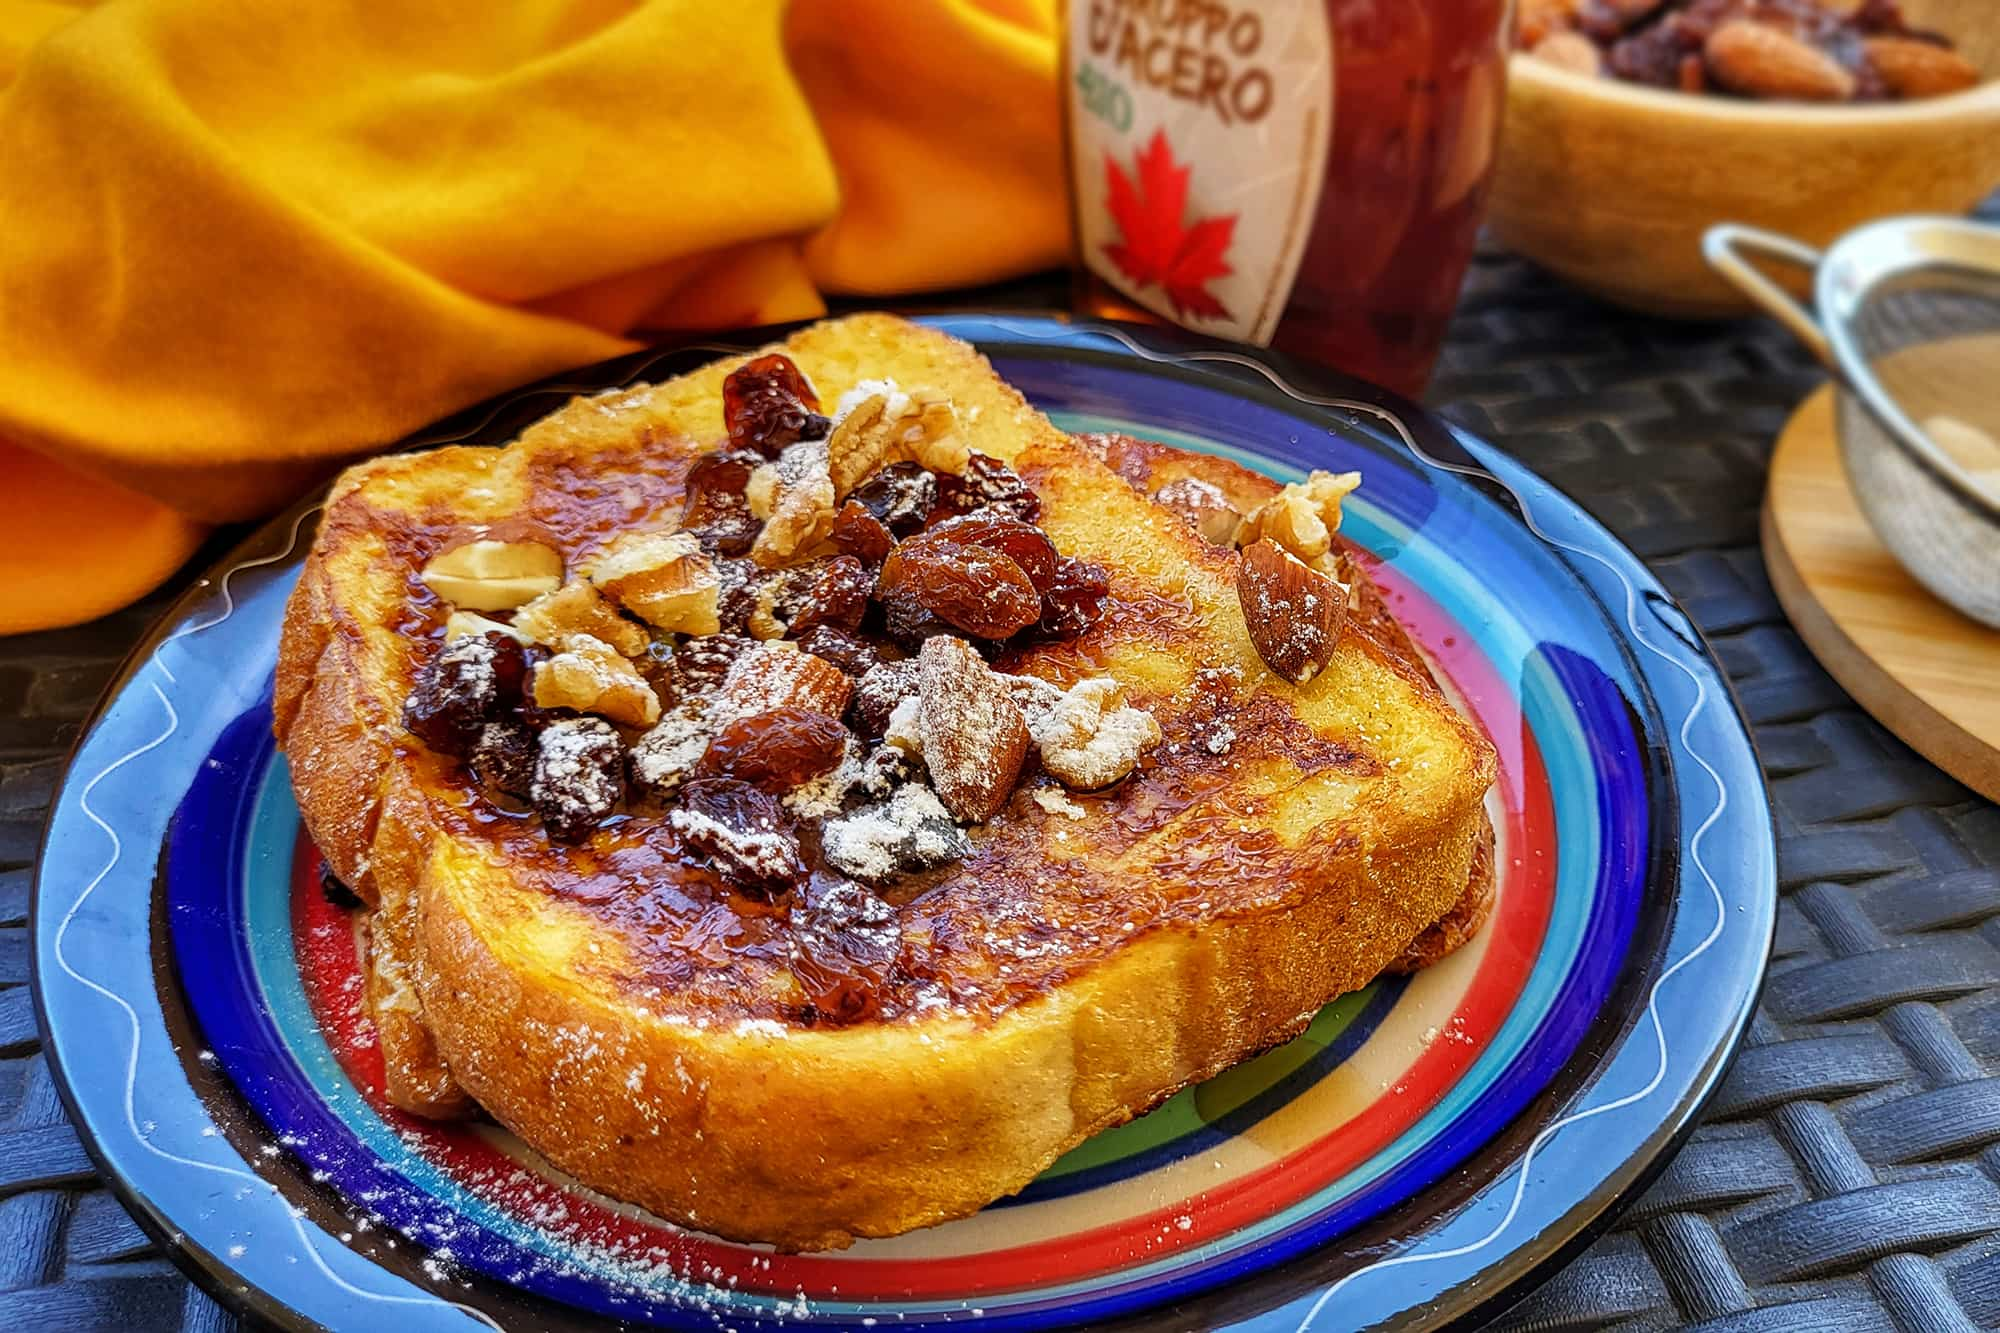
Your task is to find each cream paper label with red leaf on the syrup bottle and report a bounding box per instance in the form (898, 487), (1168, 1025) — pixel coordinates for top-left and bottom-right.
(1064, 0), (1334, 344)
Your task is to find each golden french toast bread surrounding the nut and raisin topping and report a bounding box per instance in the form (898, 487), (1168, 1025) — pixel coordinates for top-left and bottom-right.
(276, 316), (1494, 1249)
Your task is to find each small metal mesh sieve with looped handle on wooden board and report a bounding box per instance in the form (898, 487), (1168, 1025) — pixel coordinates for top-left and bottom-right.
(1702, 218), (2000, 626)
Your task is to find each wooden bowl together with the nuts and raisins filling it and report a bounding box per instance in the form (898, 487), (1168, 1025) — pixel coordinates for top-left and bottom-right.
(1490, 0), (2000, 318)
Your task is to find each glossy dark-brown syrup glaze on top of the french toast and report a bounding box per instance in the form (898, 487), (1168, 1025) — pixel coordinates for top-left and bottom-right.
(348, 420), (1424, 1023)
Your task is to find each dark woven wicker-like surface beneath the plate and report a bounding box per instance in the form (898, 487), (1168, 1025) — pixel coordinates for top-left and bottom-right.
(0, 241), (2000, 1333)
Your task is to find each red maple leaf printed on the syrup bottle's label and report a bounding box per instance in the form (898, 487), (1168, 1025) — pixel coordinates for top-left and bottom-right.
(1104, 130), (1236, 320)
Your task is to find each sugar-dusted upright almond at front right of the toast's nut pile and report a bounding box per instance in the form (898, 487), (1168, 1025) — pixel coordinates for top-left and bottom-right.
(916, 634), (1030, 825)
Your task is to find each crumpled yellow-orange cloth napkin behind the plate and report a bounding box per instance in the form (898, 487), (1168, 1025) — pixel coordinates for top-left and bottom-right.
(0, 0), (1066, 632)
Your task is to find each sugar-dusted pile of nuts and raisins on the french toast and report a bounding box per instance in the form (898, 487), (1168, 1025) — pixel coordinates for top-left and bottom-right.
(404, 354), (1168, 856)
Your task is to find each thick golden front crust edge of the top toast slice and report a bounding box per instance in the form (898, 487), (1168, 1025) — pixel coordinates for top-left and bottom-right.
(424, 792), (1484, 1249)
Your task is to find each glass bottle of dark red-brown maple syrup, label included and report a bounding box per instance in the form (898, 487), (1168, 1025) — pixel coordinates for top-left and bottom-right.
(1062, 0), (1512, 396)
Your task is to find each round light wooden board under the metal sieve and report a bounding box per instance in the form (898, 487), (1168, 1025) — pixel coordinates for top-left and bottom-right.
(1764, 386), (2000, 801)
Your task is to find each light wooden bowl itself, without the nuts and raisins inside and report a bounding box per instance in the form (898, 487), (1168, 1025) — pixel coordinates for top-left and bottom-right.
(1488, 0), (2000, 318)
